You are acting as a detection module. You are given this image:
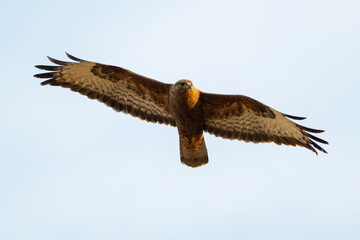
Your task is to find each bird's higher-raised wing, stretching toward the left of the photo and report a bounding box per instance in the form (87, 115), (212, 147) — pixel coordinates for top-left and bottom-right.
(34, 54), (176, 126)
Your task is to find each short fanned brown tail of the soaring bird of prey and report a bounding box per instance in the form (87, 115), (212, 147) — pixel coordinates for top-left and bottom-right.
(180, 136), (209, 167)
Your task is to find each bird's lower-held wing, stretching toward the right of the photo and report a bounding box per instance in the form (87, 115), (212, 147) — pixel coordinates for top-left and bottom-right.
(200, 93), (328, 153)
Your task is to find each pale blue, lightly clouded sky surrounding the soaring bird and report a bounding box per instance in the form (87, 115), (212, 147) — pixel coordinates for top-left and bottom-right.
(0, 0), (360, 240)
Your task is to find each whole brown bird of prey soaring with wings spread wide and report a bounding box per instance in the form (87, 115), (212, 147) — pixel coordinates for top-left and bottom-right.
(34, 53), (328, 167)
